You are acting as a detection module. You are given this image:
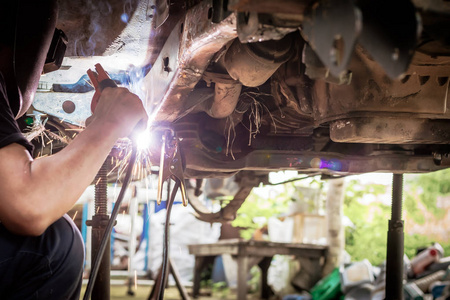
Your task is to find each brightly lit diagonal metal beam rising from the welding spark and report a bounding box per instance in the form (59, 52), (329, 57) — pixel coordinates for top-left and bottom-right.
(143, 1), (237, 122)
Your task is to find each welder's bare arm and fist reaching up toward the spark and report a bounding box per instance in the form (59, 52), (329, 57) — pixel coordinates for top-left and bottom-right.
(0, 88), (146, 235)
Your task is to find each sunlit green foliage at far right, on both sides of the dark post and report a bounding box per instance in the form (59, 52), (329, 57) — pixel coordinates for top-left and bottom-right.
(344, 175), (450, 265)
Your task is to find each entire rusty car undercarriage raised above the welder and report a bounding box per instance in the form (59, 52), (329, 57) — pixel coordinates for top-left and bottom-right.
(29, 0), (450, 196)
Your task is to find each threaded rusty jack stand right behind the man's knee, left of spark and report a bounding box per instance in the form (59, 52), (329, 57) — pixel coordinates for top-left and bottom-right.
(86, 156), (111, 300)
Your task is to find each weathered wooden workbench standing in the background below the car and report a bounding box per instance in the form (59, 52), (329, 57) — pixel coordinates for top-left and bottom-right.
(188, 239), (327, 300)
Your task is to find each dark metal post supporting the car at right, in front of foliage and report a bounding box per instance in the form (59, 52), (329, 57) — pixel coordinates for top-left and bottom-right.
(385, 174), (404, 300)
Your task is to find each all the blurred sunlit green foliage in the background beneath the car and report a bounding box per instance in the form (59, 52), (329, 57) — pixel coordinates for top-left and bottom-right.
(232, 169), (450, 265)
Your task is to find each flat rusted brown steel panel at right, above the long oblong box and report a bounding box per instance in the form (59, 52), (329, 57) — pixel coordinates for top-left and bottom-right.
(312, 47), (450, 124)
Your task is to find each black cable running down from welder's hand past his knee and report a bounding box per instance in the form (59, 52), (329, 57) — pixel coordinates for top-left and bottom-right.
(83, 142), (138, 300)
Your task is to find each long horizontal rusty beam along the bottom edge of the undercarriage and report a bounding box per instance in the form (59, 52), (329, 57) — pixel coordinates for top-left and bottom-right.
(181, 145), (444, 178)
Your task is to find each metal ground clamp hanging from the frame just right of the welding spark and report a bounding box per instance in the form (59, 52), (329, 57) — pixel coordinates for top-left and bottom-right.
(157, 130), (188, 206)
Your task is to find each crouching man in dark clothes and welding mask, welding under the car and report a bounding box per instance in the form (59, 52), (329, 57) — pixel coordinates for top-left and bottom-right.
(0, 0), (147, 300)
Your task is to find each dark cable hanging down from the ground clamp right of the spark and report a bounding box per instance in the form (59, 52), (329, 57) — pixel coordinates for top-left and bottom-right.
(156, 180), (180, 300)
